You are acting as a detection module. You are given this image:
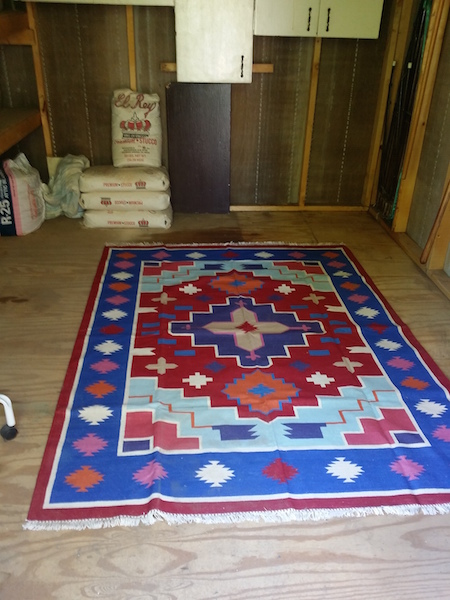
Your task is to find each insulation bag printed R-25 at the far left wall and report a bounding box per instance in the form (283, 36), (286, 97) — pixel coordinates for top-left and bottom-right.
(0, 153), (45, 235)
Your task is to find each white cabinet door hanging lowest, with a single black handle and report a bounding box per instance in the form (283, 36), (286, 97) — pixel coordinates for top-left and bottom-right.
(175, 0), (253, 83)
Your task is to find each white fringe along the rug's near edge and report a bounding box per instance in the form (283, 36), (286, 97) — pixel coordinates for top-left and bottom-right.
(23, 503), (450, 531)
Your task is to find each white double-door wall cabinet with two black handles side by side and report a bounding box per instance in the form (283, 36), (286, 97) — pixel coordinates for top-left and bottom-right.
(255, 0), (383, 38)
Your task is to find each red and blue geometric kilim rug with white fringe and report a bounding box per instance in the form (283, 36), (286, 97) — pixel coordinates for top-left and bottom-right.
(25, 244), (450, 529)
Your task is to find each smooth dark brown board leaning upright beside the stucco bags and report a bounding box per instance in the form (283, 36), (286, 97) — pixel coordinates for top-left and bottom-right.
(167, 83), (231, 213)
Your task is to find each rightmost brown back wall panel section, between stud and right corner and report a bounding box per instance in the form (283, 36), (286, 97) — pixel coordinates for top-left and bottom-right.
(305, 5), (389, 207)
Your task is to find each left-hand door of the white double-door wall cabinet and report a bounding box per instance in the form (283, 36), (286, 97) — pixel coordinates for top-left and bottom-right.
(255, 0), (320, 37)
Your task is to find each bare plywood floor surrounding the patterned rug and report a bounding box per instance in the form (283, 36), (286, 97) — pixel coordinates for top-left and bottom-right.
(0, 213), (450, 600)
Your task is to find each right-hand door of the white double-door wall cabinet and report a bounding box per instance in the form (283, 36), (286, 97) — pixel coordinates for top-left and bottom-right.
(317, 0), (383, 38)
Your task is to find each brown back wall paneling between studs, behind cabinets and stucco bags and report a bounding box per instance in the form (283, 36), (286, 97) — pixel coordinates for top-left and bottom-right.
(29, 0), (392, 208)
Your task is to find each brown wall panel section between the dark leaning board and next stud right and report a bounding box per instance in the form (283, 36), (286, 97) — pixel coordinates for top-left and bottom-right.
(231, 37), (314, 210)
